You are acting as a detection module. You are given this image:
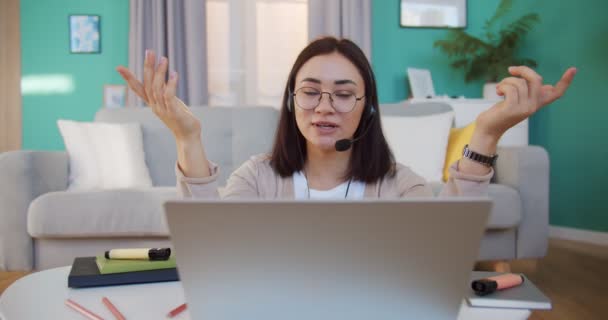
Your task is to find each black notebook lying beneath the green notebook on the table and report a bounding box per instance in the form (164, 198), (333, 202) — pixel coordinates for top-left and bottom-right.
(68, 257), (179, 288)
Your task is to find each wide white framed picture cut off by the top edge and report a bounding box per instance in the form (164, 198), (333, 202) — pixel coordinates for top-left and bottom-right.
(399, 0), (467, 28)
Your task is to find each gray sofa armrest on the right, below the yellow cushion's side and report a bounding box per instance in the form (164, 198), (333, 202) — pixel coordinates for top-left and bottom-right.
(495, 146), (549, 259)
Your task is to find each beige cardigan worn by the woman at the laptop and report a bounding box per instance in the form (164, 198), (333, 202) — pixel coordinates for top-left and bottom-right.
(175, 155), (494, 200)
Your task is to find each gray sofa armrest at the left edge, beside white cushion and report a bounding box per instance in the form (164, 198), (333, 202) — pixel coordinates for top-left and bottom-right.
(0, 151), (68, 270)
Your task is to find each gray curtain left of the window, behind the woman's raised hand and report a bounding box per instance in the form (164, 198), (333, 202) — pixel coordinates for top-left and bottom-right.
(127, 0), (208, 106)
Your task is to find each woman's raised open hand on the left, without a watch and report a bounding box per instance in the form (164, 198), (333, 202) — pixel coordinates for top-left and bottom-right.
(116, 50), (201, 141)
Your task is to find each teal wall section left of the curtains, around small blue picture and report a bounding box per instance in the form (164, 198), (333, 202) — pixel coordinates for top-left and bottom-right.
(21, 0), (129, 150)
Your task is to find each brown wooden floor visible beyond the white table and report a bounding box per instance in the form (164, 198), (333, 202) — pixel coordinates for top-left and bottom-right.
(0, 239), (608, 320)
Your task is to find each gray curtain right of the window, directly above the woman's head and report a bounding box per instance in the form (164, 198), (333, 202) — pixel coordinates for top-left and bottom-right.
(308, 0), (370, 61)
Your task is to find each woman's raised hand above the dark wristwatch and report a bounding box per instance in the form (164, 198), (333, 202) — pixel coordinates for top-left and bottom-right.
(476, 66), (577, 141)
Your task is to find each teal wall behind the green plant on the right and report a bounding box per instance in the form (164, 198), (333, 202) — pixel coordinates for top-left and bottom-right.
(372, 0), (608, 232)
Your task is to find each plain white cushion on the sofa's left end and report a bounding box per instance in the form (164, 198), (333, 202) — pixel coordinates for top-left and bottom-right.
(57, 120), (152, 190)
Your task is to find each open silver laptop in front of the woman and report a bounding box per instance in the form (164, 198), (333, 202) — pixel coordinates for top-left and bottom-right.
(165, 199), (491, 320)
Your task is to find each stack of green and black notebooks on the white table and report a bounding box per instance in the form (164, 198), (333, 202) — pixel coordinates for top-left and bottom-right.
(68, 255), (179, 288)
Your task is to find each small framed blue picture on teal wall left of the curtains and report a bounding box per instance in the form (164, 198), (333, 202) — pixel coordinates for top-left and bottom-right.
(69, 15), (101, 53)
